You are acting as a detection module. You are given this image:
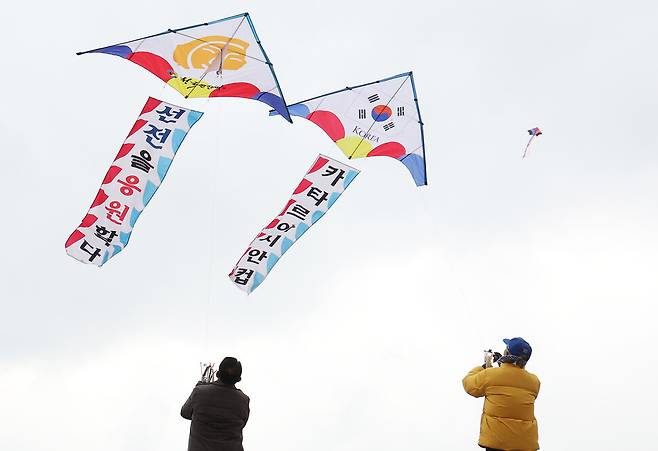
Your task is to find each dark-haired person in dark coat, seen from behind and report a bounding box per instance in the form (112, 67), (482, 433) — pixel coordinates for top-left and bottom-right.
(180, 357), (249, 451)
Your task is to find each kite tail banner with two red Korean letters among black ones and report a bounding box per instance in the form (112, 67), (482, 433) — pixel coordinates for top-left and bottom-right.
(65, 97), (203, 266)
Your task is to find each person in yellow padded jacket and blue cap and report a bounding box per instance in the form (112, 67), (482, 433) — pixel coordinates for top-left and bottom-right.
(462, 337), (539, 451)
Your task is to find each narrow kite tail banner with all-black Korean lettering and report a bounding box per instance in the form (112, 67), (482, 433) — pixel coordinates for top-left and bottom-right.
(229, 155), (359, 294)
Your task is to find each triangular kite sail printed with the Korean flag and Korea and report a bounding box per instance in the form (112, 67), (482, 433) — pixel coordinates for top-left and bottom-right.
(270, 72), (427, 186)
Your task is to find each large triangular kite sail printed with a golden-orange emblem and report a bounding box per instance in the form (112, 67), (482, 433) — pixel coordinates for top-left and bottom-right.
(78, 13), (292, 122)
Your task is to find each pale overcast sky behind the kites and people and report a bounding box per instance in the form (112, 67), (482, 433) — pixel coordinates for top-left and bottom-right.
(0, 0), (658, 451)
